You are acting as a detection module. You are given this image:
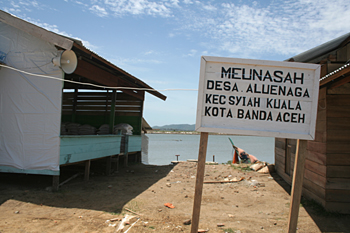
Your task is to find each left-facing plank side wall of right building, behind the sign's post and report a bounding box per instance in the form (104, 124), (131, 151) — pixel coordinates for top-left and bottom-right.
(275, 89), (327, 206)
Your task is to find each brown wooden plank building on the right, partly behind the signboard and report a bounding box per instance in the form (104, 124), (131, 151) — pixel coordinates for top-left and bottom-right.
(275, 33), (350, 214)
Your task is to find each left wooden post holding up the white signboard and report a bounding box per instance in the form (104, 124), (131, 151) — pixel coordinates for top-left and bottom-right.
(191, 132), (208, 233)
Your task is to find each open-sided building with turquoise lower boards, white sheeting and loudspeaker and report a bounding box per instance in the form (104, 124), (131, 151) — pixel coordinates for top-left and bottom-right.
(0, 11), (166, 187)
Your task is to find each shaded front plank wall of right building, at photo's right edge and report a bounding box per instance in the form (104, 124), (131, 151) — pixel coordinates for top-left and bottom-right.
(326, 83), (350, 214)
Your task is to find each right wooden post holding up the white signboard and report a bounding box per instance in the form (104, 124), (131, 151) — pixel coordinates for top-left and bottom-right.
(288, 139), (307, 233)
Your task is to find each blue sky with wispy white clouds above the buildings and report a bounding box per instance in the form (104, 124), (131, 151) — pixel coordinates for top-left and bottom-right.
(0, 0), (350, 126)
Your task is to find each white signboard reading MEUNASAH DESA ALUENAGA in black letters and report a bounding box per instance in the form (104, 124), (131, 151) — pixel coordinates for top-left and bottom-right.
(196, 56), (320, 140)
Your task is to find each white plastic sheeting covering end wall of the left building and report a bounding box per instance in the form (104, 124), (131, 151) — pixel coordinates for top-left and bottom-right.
(0, 22), (63, 171)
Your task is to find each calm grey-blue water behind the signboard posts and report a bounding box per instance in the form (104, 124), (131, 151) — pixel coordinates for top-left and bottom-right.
(143, 134), (275, 165)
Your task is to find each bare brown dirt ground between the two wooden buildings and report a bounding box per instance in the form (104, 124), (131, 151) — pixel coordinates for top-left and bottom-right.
(0, 162), (350, 233)
